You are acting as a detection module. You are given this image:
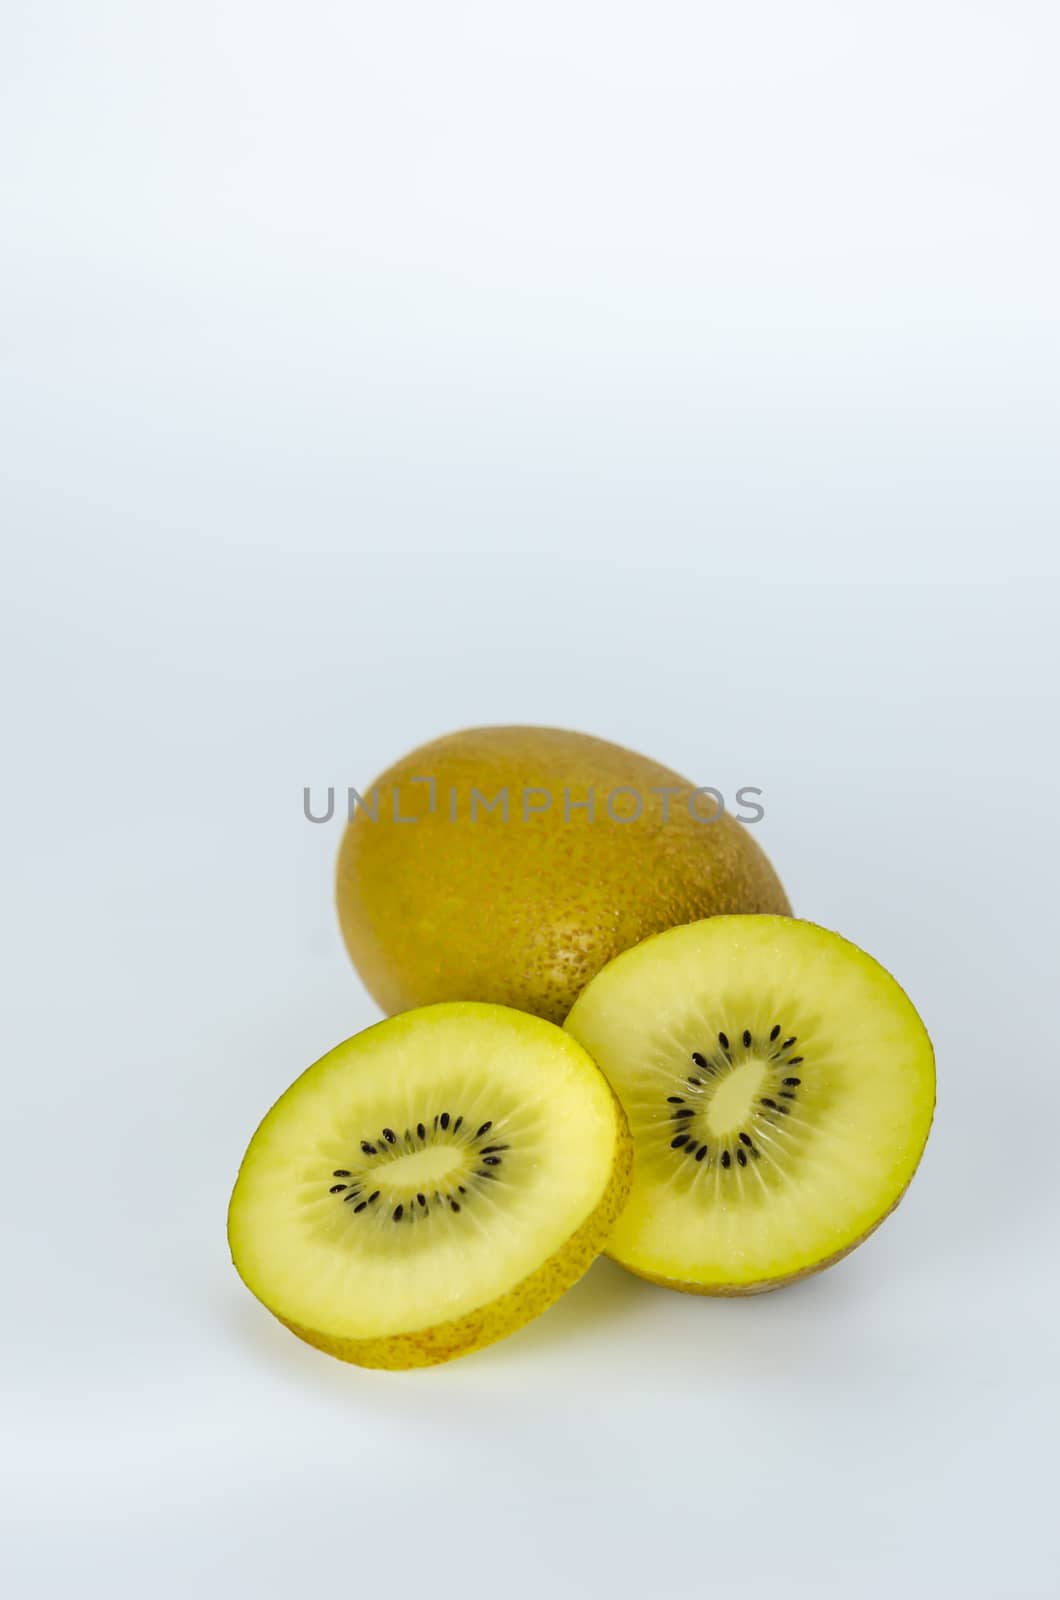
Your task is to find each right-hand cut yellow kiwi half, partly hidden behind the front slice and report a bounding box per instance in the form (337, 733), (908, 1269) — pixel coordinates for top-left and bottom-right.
(567, 915), (935, 1294)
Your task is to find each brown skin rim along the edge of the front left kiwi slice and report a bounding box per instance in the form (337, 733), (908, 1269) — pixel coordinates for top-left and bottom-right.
(279, 1099), (632, 1371)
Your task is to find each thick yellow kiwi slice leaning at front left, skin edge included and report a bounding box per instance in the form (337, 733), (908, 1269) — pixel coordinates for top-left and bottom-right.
(229, 1002), (632, 1368)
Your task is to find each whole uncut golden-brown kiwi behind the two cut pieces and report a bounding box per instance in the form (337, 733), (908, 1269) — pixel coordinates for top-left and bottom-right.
(338, 726), (791, 1022)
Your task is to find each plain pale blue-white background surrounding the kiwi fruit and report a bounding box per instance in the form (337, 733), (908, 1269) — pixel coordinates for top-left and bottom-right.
(0, 0), (1060, 1600)
